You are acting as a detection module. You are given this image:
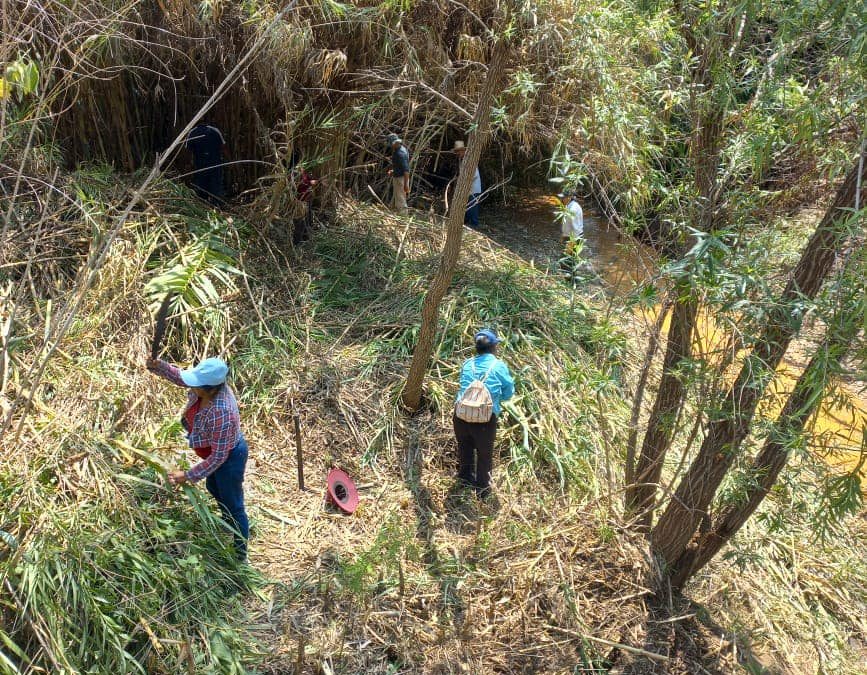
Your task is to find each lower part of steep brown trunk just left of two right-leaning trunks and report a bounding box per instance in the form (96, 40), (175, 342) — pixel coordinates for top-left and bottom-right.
(626, 294), (698, 529)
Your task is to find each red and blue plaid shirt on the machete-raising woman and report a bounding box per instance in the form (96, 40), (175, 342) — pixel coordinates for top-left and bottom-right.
(154, 360), (241, 482)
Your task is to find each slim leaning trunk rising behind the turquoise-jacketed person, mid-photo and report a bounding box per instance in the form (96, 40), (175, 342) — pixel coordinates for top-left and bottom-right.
(402, 38), (509, 410)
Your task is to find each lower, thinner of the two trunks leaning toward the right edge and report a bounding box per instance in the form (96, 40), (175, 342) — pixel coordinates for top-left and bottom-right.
(671, 302), (864, 588)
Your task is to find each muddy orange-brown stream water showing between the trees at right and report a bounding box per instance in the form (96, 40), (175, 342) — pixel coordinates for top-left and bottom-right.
(481, 193), (867, 480)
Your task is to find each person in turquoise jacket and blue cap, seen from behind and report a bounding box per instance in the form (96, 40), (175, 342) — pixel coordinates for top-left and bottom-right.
(452, 328), (515, 498)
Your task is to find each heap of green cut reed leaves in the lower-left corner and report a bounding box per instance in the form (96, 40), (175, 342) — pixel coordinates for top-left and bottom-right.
(0, 445), (261, 673)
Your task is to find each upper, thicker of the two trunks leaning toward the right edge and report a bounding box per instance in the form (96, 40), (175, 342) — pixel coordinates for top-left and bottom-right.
(651, 164), (867, 578)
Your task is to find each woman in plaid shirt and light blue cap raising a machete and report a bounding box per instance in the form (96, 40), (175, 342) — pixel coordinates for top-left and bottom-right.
(146, 358), (250, 560)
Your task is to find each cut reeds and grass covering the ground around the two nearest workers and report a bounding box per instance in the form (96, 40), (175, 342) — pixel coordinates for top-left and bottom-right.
(0, 177), (647, 673)
